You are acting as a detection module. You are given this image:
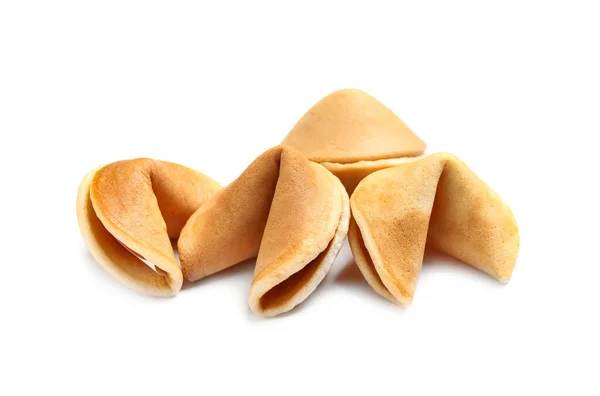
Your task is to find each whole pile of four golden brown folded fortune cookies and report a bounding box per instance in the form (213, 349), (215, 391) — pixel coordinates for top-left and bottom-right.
(77, 89), (519, 316)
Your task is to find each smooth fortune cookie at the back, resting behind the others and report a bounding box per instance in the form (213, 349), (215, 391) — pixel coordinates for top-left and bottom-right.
(282, 89), (426, 194)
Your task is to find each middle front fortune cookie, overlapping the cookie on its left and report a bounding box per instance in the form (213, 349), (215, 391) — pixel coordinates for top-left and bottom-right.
(178, 146), (350, 316)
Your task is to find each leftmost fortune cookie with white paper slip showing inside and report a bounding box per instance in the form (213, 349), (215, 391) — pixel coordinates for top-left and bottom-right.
(77, 159), (220, 296)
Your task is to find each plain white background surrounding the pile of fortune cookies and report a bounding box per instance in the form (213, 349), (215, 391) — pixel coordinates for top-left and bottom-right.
(0, 0), (600, 395)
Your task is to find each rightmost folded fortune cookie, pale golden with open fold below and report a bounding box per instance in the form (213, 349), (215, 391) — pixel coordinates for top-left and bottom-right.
(348, 153), (519, 305)
